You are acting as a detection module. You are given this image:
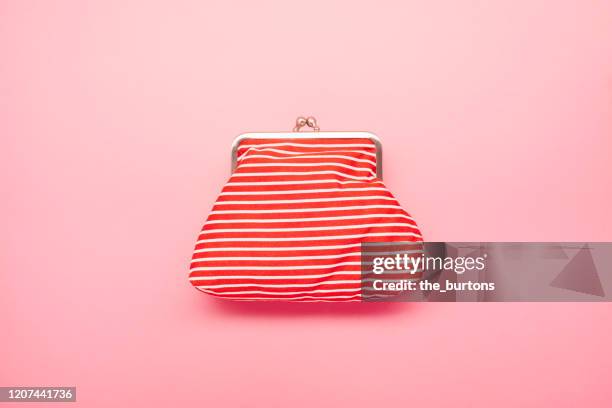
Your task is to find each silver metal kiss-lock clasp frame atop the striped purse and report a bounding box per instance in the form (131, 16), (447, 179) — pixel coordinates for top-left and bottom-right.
(232, 116), (383, 180)
